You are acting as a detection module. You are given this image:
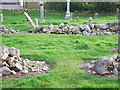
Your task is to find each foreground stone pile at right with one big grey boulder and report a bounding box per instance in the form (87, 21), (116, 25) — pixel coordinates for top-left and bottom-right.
(82, 55), (120, 76)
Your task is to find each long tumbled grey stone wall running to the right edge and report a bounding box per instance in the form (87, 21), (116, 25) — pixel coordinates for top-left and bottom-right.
(29, 21), (119, 35)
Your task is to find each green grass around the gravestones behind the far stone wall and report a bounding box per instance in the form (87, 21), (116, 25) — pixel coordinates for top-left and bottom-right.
(2, 10), (117, 31)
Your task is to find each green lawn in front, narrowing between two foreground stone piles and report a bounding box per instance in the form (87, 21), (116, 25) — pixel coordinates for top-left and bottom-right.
(2, 34), (118, 88)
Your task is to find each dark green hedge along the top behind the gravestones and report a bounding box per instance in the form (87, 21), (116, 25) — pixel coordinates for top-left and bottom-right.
(24, 2), (120, 13)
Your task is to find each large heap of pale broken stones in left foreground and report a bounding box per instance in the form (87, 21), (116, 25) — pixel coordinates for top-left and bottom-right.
(0, 46), (50, 77)
